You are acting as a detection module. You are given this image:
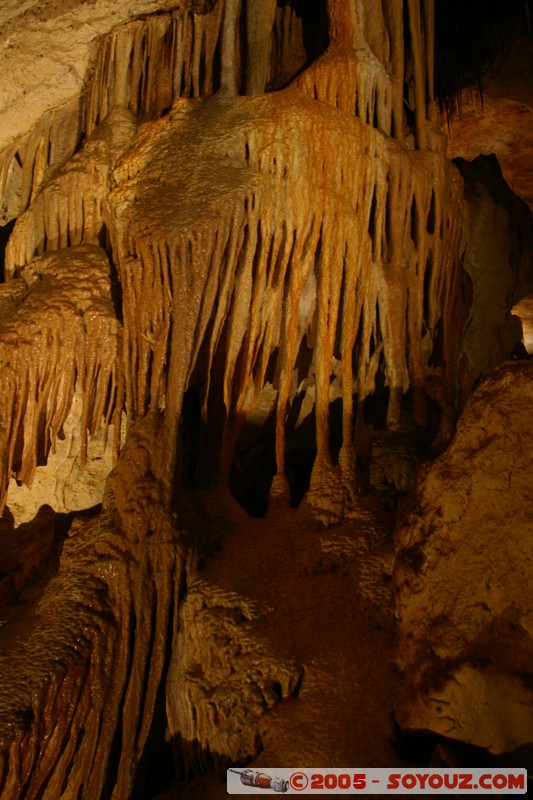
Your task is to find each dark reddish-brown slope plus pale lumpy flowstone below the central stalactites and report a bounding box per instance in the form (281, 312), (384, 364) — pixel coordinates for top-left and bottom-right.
(167, 496), (399, 784)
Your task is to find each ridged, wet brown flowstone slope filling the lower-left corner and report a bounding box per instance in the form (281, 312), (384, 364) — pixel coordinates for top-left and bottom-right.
(0, 416), (196, 798)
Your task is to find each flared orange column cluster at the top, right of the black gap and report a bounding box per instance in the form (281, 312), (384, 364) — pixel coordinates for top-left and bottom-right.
(296, 0), (437, 149)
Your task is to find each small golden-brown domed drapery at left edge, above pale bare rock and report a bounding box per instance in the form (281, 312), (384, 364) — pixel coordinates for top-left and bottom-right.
(0, 246), (122, 513)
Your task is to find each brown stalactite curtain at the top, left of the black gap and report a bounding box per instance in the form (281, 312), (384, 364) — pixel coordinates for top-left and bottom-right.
(85, 0), (306, 138)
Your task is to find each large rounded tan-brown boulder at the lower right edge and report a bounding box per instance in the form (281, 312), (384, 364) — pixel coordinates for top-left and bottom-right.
(394, 362), (533, 753)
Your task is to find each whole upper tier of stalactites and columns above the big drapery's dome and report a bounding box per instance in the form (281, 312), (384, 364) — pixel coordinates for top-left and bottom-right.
(0, 0), (434, 231)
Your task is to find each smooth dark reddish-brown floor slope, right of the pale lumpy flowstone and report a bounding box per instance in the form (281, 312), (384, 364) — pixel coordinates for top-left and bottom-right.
(164, 490), (405, 800)
